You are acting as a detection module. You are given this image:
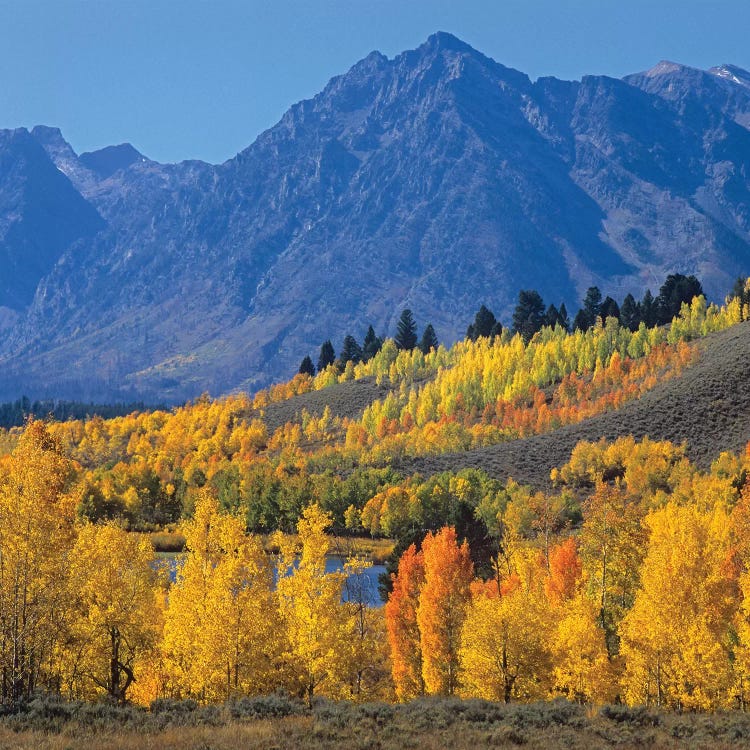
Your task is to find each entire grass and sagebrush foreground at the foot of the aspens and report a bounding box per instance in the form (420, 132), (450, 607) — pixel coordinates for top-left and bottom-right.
(0, 696), (750, 750)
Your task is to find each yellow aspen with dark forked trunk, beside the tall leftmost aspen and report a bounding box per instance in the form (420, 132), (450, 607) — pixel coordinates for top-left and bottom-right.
(62, 525), (158, 703)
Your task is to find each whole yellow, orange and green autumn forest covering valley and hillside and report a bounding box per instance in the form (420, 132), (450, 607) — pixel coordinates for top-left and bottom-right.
(0, 284), (750, 736)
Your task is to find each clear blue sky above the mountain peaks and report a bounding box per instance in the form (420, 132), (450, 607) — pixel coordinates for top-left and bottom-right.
(0, 0), (750, 162)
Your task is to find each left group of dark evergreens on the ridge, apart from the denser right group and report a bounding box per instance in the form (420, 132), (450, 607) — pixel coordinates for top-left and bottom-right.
(299, 307), (439, 377)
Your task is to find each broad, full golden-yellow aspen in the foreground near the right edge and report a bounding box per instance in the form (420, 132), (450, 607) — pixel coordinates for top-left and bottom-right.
(621, 502), (736, 710)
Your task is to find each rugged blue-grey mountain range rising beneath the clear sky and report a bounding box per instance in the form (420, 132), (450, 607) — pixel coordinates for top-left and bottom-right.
(0, 34), (750, 400)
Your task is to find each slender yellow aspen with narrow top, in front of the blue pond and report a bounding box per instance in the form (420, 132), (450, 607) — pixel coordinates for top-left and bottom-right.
(276, 504), (346, 703)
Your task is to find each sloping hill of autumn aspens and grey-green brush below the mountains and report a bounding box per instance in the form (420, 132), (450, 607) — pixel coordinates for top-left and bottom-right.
(3, 282), (750, 531)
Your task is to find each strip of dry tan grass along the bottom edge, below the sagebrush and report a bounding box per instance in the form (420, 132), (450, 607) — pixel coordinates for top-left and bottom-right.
(0, 717), (748, 750)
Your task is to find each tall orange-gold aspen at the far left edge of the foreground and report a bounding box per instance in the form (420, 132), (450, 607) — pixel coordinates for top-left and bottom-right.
(0, 421), (76, 704)
